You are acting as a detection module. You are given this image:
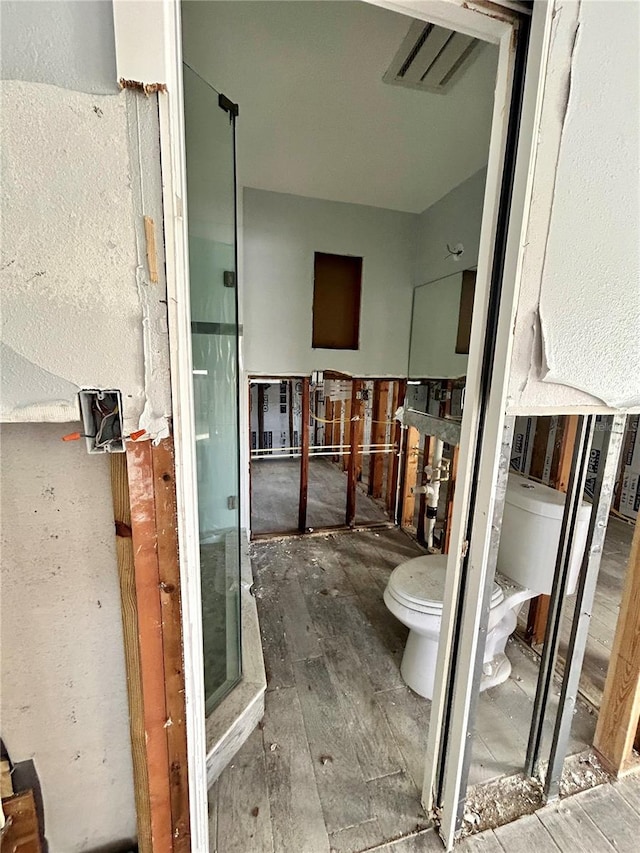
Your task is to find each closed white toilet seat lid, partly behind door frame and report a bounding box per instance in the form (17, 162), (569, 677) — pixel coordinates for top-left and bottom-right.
(389, 554), (504, 612)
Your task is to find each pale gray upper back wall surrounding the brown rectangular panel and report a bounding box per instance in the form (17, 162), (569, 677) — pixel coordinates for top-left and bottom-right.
(243, 188), (416, 376)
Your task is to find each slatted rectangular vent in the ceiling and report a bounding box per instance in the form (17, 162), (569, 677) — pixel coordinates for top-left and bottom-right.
(382, 21), (480, 93)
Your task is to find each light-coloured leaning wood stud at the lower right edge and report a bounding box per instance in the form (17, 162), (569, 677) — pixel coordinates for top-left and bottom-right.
(593, 510), (640, 775)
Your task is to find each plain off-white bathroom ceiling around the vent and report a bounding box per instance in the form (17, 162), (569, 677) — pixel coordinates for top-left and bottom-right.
(183, 0), (497, 213)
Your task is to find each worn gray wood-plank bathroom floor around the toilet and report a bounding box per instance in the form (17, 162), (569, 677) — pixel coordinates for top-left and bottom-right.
(211, 529), (594, 853)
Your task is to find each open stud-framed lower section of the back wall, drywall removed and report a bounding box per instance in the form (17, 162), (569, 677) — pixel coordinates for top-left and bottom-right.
(249, 371), (406, 539)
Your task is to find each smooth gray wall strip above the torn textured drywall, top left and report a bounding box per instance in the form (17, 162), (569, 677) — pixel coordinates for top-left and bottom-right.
(0, 0), (118, 94)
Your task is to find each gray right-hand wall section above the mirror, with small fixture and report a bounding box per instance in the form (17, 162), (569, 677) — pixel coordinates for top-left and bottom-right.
(413, 169), (487, 286)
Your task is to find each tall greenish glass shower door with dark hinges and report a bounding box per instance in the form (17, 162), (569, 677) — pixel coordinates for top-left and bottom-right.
(184, 64), (241, 714)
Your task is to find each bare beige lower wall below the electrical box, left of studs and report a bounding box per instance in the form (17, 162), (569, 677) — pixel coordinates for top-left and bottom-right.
(1, 424), (136, 853)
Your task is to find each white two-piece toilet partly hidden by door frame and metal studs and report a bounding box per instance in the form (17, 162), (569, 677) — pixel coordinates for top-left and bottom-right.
(384, 474), (591, 699)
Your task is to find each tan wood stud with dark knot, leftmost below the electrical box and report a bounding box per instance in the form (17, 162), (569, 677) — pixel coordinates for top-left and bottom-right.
(109, 453), (153, 853)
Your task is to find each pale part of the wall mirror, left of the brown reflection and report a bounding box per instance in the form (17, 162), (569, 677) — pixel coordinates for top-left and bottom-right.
(409, 272), (468, 379)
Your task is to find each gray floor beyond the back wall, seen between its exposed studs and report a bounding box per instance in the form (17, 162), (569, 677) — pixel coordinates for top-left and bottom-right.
(251, 457), (388, 535)
